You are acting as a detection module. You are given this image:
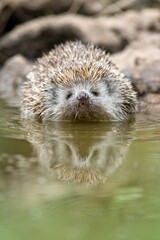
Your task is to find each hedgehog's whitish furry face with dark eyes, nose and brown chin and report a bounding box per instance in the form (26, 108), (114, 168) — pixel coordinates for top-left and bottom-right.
(43, 79), (137, 121)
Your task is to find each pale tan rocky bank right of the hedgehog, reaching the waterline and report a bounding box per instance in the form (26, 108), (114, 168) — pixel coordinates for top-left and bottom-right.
(112, 32), (160, 113)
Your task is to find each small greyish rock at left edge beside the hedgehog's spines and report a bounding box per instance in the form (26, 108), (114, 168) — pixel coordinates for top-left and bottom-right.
(0, 55), (32, 105)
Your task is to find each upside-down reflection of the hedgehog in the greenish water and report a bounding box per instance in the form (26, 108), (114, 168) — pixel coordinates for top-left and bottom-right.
(26, 122), (133, 185)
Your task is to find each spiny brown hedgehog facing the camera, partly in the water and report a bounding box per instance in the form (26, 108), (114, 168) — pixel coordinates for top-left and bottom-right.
(21, 41), (137, 122)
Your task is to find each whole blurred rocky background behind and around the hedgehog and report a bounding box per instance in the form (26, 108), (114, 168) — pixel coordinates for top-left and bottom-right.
(0, 0), (160, 112)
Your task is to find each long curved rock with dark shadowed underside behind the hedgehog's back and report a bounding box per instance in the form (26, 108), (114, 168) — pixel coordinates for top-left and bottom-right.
(0, 15), (126, 63)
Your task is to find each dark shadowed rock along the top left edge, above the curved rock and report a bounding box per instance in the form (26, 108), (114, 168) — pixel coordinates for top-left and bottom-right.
(0, 0), (103, 34)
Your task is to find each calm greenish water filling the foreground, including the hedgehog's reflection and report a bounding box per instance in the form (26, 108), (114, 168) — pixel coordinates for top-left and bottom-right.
(0, 102), (160, 240)
